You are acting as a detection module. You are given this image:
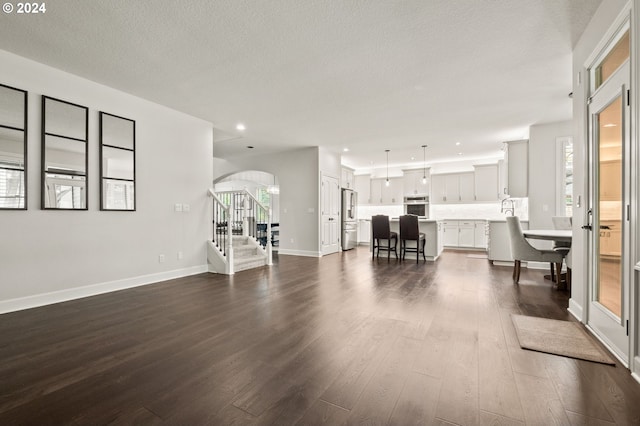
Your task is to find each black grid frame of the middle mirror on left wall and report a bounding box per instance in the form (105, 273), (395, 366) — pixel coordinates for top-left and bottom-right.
(41, 95), (89, 210)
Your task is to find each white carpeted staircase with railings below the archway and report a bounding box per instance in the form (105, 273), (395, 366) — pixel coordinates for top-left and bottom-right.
(207, 189), (272, 275)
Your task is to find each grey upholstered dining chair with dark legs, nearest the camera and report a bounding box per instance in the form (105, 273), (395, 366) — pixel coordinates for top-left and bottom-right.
(506, 216), (564, 284)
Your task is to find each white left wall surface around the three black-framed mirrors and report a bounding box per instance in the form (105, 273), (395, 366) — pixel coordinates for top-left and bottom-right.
(0, 51), (212, 312)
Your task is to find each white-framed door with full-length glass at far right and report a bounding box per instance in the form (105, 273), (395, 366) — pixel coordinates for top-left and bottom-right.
(587, 55), (631, 362)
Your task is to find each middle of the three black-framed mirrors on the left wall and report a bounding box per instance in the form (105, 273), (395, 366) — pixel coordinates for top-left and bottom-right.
(42, 96), (89, 210)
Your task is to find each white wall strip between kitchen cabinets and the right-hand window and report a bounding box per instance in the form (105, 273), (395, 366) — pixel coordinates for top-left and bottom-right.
(529, 120), (573, 229)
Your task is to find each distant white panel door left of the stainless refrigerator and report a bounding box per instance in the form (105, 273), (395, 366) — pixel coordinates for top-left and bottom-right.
(320, 175), (341, 255)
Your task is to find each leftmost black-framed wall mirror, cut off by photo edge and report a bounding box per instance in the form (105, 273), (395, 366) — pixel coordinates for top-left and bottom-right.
(0, 84), (27, 210)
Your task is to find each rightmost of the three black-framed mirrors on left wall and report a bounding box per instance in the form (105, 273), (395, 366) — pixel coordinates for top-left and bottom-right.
(100, 112), (136, 211)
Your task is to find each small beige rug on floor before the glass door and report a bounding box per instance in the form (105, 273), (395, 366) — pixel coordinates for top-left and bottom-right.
(511, 315), (615, 365)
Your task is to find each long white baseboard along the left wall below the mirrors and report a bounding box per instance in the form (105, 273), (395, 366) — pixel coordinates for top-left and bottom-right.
(0, 265), (208, 314)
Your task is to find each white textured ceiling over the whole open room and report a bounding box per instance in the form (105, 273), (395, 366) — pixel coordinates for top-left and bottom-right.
(0, 0), (601, 173)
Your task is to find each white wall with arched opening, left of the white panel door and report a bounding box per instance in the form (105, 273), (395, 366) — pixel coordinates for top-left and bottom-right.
(213, 147), (320, 256)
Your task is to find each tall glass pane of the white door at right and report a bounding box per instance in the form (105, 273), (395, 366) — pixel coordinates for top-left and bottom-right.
(594, 95), (624, 317)
